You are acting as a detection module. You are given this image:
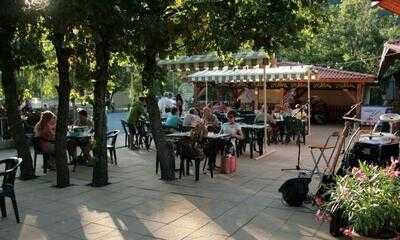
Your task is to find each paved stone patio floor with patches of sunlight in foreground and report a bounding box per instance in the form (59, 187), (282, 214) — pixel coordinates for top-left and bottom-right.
(0, 126), (338, 240)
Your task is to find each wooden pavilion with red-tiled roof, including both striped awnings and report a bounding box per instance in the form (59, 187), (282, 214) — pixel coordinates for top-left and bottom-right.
(159, 52), (376, 123)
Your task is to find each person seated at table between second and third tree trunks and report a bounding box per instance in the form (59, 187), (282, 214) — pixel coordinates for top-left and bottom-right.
(67, 109), (93, 162)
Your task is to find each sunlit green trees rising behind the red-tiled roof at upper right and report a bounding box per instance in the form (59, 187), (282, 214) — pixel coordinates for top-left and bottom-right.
(281, 0), (400, 73)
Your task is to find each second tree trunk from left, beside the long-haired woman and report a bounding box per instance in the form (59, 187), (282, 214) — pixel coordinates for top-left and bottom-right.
(53, 33), (71, 188)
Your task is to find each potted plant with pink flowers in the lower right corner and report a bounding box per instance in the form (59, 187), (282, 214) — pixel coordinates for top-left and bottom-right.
(316, 160), (400, 239)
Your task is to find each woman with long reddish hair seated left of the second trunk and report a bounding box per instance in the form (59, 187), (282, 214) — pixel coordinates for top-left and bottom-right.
(33, 111), (57, 170)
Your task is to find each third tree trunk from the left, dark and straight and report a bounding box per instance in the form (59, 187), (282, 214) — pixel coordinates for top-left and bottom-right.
(92, 35), (110, 187)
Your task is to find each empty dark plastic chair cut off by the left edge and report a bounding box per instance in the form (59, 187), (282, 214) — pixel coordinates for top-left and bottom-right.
(0, 157), (22, 223)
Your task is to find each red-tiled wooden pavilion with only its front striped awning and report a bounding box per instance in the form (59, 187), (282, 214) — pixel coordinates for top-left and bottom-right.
(187, 62), (376, 121)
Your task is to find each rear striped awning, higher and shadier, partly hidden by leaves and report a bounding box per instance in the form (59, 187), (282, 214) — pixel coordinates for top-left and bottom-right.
(158, 51), (269, 71)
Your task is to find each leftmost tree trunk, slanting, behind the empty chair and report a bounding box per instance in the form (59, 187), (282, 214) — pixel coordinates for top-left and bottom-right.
(0, 26), (35, 180)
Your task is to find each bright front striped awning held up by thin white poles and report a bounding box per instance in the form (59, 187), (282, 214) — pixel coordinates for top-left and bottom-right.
(188, 65), (318, 83)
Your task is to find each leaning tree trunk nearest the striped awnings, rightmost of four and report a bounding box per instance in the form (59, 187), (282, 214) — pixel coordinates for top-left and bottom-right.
(142, 52), (175, 181)
